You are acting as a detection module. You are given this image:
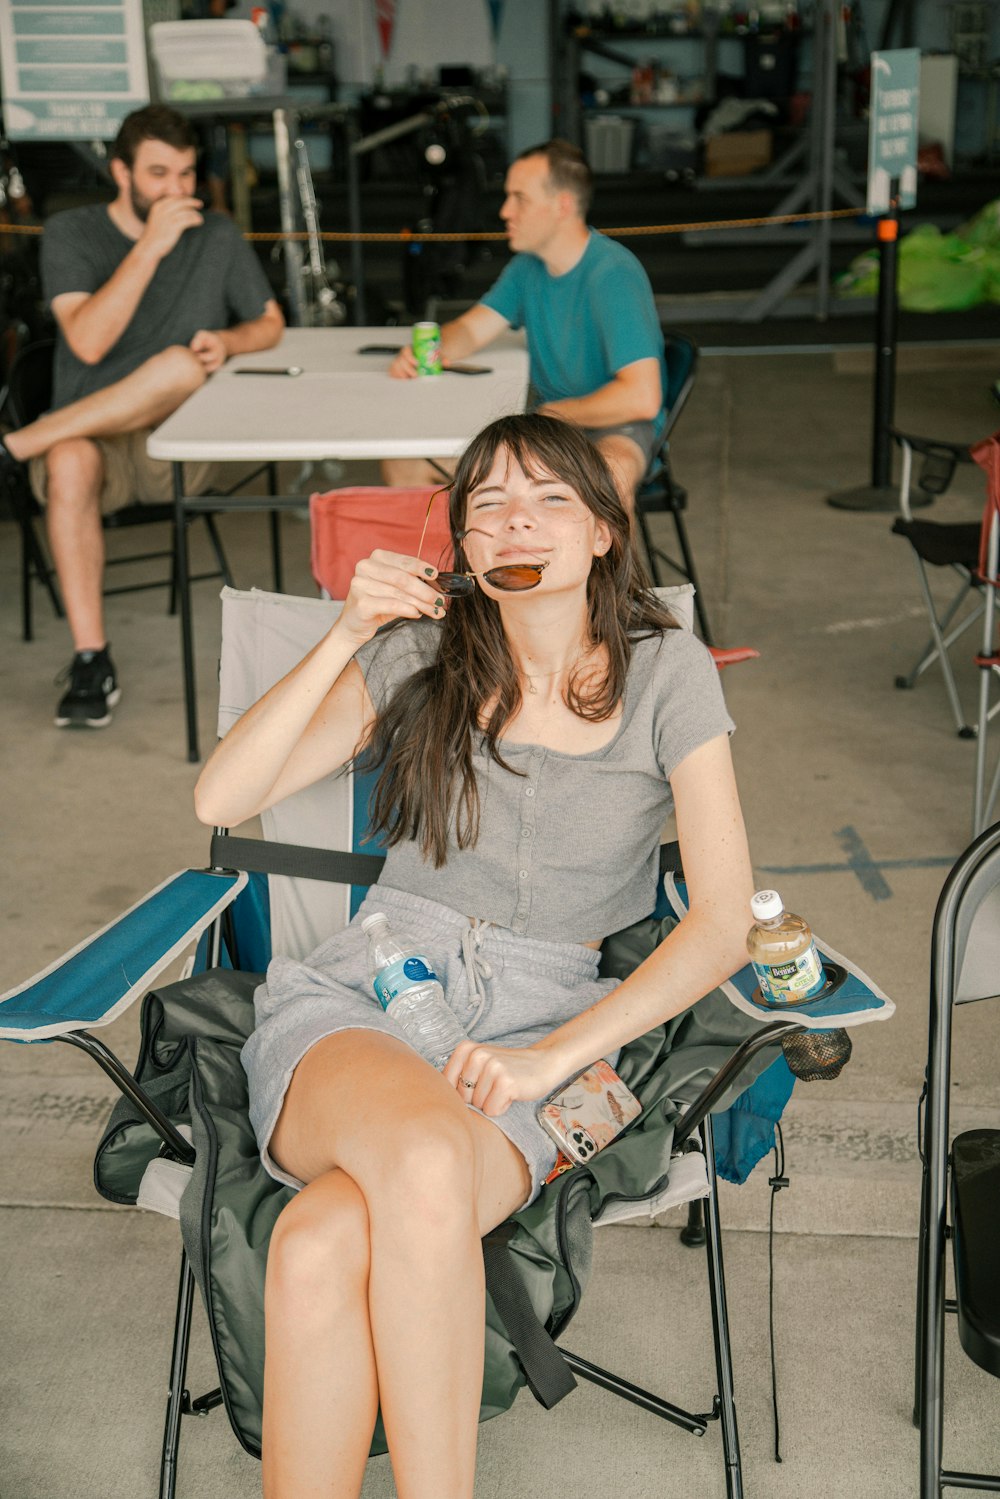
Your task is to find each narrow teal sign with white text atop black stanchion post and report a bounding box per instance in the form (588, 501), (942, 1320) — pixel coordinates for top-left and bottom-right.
(867, 46), (921, 216)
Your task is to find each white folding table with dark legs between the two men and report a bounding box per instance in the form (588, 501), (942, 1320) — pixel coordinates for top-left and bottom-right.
(147, 328), (528, 761)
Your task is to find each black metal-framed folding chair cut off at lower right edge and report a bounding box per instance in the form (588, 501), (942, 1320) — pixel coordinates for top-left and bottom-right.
(915, 824), (1000, 1499)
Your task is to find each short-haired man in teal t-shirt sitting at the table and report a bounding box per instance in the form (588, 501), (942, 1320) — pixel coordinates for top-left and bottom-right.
(385, 141), (666, 510)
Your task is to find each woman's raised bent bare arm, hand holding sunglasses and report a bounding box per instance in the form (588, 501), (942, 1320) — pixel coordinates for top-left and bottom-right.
(195, 552), (442, 827)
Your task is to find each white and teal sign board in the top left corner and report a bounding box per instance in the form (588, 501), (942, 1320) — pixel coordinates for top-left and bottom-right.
(0, 0), (150, 141)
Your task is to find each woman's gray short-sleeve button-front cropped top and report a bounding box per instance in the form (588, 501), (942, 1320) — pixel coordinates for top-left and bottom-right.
(355, 621), (733, 943)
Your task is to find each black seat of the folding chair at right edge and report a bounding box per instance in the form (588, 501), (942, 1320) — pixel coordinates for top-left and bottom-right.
(952, 1129), (1000, 1378)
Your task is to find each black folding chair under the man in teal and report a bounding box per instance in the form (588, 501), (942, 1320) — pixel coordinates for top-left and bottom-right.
(636, 328), (714, 646)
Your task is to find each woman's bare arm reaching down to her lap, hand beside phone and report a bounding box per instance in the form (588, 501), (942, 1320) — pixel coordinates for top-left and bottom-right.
(445, 735), (754, 1115)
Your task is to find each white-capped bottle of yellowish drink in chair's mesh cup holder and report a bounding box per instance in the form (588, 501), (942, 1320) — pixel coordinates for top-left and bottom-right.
(747, 890), (852, 1082)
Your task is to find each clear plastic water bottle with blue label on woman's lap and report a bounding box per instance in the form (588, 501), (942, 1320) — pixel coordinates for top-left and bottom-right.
(361, 911), (466, 1072)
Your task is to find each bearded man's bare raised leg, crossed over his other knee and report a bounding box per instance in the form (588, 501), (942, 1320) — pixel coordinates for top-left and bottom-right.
(3, 343), (205, 462)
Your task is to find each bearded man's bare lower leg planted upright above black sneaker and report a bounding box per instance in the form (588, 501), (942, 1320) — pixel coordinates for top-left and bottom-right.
(45, 438), (106, 651)
